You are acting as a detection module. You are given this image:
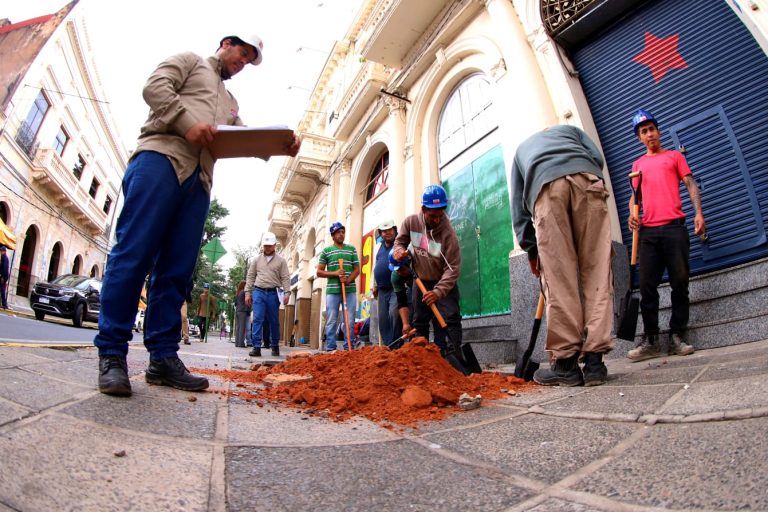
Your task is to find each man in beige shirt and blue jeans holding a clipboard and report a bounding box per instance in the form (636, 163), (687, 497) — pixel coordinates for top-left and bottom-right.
(94, 33), (300, 396)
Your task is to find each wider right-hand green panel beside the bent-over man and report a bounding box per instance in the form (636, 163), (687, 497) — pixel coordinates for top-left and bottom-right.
(472, 142), (514, 315)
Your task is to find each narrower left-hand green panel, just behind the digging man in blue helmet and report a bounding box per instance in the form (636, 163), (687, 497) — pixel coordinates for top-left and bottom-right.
(443, 166), (482, 316)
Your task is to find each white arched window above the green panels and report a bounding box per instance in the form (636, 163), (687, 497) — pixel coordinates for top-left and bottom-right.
(437, 74), (497, 167)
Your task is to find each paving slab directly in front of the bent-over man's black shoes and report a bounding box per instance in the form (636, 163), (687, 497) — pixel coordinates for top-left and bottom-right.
(540, 384), (682, 414)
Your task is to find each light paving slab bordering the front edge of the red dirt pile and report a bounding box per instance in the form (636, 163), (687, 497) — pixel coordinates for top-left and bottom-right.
(229, 402), (398, 446)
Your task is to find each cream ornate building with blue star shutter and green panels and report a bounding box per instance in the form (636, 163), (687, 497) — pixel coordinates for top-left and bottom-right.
(270, 0), (768, 362)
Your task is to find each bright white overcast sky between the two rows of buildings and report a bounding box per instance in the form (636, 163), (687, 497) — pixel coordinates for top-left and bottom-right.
(0, 0), (361, 267)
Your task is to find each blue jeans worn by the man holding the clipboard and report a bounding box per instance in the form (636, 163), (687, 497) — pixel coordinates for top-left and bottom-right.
(93, 151), (210, 359)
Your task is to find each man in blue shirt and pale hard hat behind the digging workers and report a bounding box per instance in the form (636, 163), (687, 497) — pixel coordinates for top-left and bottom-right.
(373, 220), (403, 345)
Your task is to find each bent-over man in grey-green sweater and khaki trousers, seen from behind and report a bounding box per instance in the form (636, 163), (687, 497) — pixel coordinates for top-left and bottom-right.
(512, 125), (613, 386)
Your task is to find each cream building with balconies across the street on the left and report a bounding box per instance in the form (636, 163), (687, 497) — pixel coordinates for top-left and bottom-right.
(0, 1), (128, 307)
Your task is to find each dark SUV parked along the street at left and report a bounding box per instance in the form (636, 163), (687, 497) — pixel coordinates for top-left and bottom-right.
(29, 274), (101, 327)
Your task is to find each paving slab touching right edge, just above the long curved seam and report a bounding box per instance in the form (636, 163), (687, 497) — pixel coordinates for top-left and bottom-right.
(664, 374), (768, 414)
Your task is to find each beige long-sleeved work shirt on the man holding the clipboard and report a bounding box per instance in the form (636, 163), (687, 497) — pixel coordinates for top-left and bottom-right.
(133, 52), (243, 192)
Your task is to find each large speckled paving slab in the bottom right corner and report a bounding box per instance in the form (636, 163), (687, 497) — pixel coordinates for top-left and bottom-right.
(575, 419), (768, 510)
